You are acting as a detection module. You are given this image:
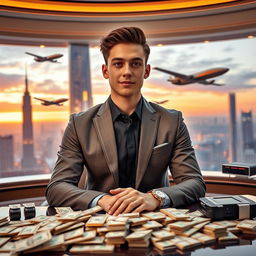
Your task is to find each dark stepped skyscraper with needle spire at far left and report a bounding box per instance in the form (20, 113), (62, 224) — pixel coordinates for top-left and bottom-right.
(21, 66), (36, 169)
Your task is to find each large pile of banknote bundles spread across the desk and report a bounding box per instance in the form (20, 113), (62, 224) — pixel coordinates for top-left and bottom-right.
(0, 206), (256, 255)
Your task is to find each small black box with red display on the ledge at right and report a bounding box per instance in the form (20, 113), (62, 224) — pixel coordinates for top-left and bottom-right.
(222, 163), (256, 176)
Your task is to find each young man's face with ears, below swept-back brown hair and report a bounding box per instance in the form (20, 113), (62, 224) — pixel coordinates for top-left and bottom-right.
(102, 43), (150, 97)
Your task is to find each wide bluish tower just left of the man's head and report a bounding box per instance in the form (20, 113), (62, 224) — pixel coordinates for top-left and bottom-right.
(69, 44), (92, 113)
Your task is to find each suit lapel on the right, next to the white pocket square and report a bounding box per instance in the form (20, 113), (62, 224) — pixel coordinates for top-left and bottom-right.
(135, 98), (159, 189)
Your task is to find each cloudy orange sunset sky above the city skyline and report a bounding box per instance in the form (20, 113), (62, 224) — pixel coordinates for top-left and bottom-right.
(0, 38), (256, 124)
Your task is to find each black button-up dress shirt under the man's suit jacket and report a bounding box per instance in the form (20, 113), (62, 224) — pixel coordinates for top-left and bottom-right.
(109, 97), (143, 188)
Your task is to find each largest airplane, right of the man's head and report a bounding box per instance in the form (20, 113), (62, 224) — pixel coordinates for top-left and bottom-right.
(154, 67), (229, 86)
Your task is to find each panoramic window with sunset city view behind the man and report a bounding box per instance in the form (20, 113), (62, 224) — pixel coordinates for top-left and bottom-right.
(0, 39), (256, 177)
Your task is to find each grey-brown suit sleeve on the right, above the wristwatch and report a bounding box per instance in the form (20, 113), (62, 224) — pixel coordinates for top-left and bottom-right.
(158, 112), (206, 207)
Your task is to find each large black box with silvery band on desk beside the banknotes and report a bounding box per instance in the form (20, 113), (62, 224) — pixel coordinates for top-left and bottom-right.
(199, 195), (256, 220)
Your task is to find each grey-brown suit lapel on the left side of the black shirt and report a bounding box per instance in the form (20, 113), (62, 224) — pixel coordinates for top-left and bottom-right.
(93, 101), (119, 186)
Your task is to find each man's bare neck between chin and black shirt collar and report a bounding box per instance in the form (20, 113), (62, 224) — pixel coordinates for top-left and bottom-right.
(111, 94), (141, 115)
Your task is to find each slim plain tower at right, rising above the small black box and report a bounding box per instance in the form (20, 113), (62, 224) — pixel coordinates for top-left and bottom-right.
(229, 93), (237, 162)
